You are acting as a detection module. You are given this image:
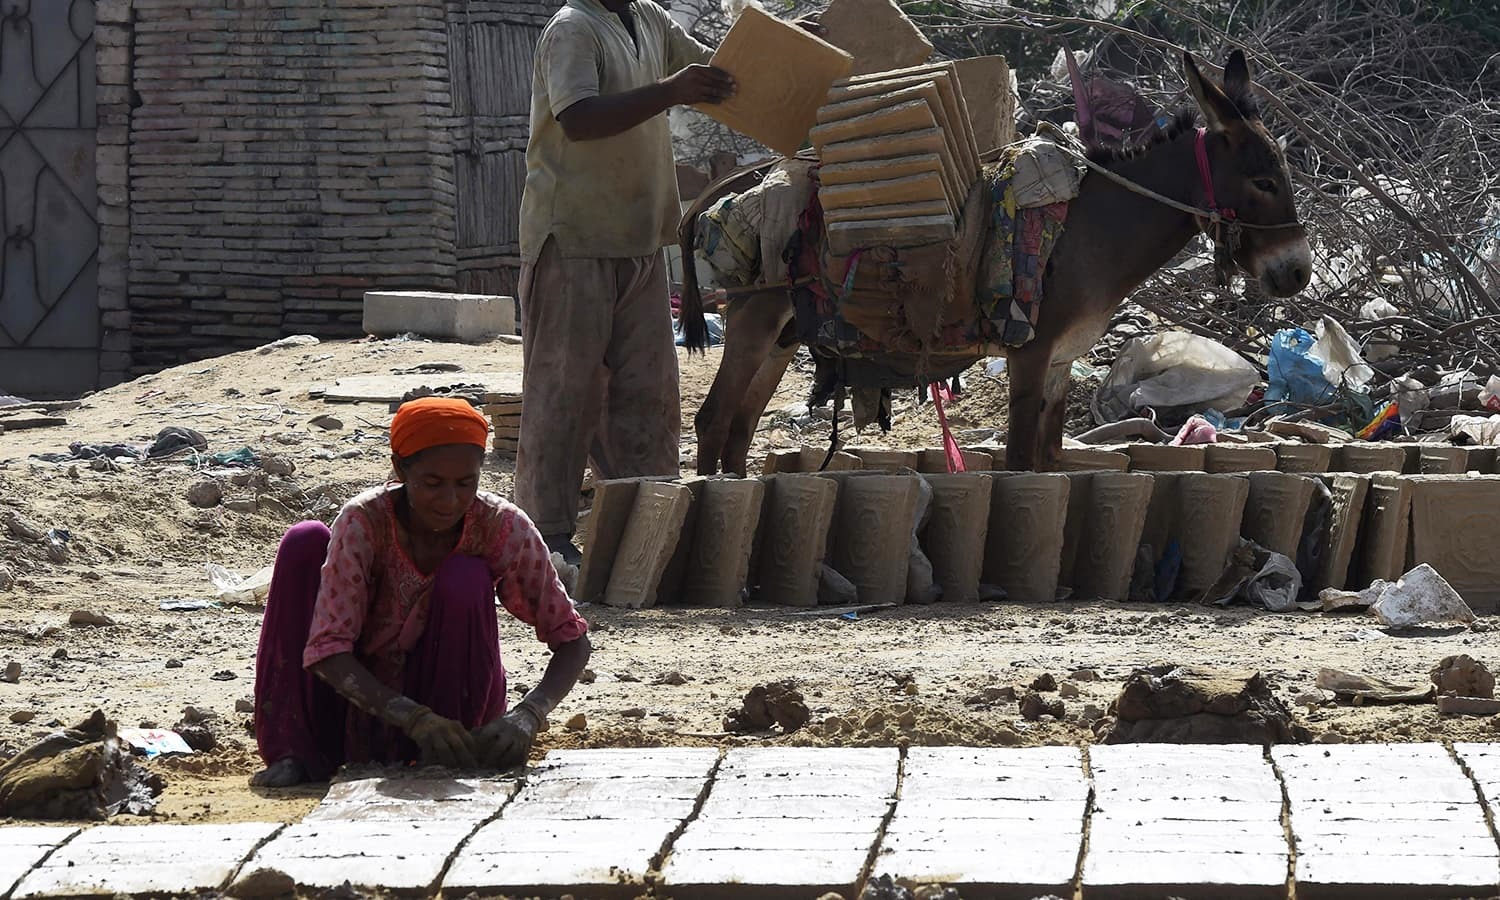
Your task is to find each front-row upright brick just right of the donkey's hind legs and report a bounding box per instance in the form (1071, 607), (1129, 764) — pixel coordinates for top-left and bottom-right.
(756, 476), (839, 606)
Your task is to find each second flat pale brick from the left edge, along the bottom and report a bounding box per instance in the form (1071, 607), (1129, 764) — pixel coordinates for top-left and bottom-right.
(11, 822), (281, 900)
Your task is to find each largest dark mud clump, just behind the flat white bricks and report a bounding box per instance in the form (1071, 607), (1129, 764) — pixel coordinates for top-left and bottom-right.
(1097, 666), (1310, 746)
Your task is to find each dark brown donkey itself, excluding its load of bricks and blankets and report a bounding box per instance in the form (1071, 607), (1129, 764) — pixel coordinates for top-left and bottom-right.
(681, 50), (1313, 476)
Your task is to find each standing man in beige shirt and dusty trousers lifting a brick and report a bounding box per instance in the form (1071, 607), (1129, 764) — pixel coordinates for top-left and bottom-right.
(516, 0), (735, 564)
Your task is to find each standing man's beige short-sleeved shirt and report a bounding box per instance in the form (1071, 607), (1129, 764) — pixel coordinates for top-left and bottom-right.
(521, 0), (713, 263)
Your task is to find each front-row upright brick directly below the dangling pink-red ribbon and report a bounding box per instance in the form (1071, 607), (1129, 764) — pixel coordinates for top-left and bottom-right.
(921, 473), (996, 603)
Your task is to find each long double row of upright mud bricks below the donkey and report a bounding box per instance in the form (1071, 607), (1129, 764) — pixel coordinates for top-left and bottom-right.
(576, 443), (1500, 612)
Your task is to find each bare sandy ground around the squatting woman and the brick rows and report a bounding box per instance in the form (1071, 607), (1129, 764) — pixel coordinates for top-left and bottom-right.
(0, 341), (1500, 821)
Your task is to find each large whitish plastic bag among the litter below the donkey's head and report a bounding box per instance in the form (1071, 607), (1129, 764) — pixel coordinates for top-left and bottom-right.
(1092, 332), (1260, 426)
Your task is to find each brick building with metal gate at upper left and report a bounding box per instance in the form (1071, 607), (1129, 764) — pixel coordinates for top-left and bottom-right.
(0, 0), (557, 396)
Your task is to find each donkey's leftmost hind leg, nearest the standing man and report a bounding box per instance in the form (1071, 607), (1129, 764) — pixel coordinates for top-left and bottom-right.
(693, 291), (789, 476)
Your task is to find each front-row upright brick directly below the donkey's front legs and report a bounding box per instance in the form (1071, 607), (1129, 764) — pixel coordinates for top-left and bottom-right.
(983, 473), (1071, 603)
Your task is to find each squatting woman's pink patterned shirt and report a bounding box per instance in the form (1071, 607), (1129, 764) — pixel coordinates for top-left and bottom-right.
(302, 486), (588, 689)
